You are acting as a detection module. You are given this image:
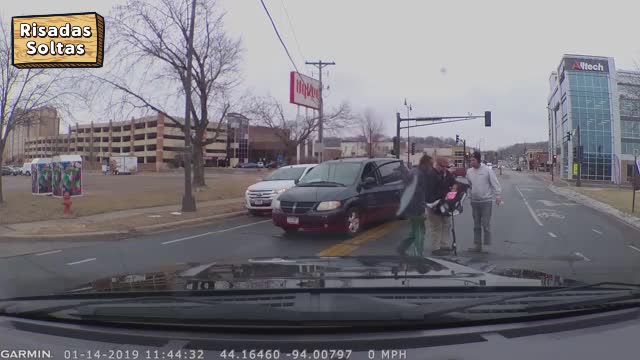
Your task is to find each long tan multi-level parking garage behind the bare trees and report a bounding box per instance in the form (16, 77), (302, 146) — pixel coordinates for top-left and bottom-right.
(25, 114), (227, 171)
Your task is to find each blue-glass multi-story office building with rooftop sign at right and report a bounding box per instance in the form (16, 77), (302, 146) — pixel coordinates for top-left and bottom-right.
(547, 55), (640, 183)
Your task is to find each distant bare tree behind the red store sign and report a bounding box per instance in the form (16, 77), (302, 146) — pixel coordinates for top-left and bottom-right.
(248, 98), (352, 161)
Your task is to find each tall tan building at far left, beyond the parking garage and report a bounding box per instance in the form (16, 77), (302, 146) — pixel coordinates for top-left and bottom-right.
(3, 107), (60, 163)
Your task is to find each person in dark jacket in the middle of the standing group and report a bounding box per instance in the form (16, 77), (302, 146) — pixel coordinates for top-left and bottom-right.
(427, 156), (456, 256)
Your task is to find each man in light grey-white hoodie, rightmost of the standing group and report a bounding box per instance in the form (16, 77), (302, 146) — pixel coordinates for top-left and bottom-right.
(467, 152), (502, 252)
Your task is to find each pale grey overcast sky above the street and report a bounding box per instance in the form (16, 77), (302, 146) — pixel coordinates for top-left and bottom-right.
(0, 0), (640, 149)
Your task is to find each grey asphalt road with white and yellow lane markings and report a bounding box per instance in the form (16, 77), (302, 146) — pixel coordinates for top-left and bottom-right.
(0, 171), (640, 298)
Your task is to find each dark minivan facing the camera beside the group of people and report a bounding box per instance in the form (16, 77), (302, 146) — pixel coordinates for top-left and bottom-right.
(272, 158), (407, 236)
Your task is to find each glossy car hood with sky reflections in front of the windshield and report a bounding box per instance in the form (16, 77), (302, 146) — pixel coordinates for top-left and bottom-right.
(67, 256), (579, 293)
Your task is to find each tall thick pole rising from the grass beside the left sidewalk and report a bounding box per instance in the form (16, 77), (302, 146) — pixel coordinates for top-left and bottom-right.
(182, 0), (196, 212)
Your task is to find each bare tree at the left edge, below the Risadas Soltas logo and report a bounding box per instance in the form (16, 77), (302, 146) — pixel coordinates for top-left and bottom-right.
(0, 23), (74, 204)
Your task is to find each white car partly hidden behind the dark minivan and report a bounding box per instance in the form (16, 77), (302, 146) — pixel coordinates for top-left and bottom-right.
(244, 164), (317, 215)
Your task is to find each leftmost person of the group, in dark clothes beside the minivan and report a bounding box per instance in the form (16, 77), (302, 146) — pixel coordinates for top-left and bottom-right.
(396, 155), (433, 256)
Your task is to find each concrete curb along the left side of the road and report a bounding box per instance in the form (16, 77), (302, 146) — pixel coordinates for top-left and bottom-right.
(0, 210), (247, 242)
